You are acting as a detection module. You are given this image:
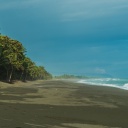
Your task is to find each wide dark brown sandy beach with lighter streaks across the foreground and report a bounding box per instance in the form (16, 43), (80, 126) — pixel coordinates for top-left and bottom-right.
(0, 80), (128, 128)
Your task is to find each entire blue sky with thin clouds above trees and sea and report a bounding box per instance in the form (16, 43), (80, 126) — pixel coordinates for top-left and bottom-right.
(0, 0), (128, 78)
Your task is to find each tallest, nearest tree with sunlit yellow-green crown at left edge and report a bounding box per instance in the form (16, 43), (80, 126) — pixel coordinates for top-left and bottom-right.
(0, 36), (25, 82)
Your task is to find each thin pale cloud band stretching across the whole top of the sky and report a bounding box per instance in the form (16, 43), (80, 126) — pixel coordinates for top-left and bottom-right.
(0, 0), (128, 21)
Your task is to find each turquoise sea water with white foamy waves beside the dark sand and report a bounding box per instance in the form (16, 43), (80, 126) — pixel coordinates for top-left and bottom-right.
(77, 78), (128, 90)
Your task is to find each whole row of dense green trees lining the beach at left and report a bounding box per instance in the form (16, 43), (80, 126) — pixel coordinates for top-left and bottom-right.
(0, 35), (52, 82)
